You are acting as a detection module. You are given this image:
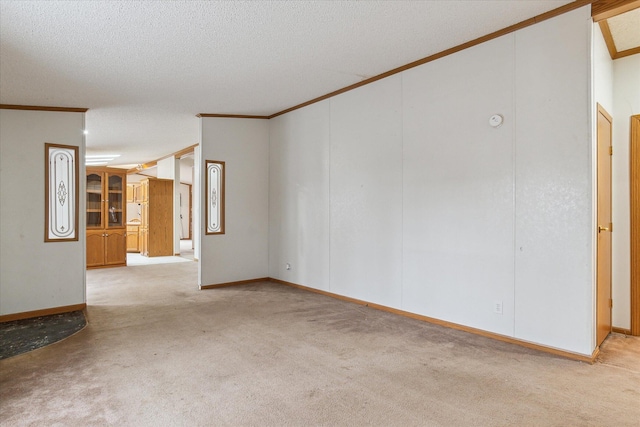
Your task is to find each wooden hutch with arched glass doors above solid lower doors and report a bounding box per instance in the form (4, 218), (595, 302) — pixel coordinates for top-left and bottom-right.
(86, 168), (127, 268)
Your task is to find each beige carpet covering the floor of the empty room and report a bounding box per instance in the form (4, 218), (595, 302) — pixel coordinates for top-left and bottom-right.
(0, 263), (640, 426)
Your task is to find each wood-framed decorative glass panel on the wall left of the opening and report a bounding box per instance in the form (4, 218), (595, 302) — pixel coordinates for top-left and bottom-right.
(44, 143), (79, 242)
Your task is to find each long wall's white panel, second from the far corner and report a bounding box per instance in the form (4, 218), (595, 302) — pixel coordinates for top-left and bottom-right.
(329, 75), (403, 308)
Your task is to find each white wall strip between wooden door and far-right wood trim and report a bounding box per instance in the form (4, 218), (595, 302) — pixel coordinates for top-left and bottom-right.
(612, 54), (640, 329)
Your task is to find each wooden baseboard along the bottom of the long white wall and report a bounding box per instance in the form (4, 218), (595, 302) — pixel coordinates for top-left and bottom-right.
(269, 278), (600, 363)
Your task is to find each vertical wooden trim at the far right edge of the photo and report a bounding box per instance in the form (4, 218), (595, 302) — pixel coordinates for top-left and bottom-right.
(629, 115), (640, 336)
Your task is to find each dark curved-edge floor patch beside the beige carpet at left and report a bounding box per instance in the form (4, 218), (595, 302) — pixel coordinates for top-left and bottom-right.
(0, 311), (87, 360)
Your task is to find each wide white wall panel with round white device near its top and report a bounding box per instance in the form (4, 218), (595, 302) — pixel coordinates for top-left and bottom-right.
(403, 35), (516, 336)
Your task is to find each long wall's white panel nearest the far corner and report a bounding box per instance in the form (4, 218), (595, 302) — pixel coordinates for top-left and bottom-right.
(269, 101), (331, 291)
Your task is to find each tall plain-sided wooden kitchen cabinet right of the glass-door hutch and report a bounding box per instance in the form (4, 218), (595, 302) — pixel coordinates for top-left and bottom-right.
(140, 178), (173, 257)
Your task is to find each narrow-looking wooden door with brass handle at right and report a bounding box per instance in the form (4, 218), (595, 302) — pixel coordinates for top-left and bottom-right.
(596, 105), (613, 345)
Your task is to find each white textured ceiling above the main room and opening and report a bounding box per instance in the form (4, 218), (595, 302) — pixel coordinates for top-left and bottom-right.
(0, 0), (570, 166)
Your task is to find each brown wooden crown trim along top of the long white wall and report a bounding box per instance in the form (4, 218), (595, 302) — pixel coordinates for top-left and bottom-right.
(267, 0), (592, 119)
